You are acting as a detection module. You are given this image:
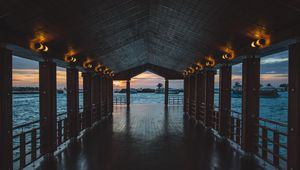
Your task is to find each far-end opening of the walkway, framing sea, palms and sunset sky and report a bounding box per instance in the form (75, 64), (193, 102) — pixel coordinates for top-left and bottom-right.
(114, 71), (183, 105)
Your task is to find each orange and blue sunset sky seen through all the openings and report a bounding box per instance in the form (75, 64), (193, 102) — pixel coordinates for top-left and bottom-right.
(13, 51), (288, 89)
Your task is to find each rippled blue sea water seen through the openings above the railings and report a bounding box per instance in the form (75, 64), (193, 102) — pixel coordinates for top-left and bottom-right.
(13, 92), (288, 126)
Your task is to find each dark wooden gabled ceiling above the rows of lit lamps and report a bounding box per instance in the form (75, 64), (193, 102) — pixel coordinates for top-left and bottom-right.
(0, 0), (300, 72)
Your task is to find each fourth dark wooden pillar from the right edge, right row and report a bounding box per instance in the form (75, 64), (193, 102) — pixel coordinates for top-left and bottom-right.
(205, 70), (215, 128)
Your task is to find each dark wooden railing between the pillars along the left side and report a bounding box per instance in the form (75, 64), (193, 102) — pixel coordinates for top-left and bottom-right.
(13, 108), (85, 169)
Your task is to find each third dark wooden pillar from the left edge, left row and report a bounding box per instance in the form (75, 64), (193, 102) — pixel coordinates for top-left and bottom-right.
(67, 68), (79, 138)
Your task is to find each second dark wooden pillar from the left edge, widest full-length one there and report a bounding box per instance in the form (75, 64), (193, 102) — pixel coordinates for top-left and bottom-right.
(39, 60), (57, 156)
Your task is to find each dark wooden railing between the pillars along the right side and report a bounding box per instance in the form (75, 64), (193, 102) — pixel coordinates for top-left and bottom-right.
(213, 107), (288, 169)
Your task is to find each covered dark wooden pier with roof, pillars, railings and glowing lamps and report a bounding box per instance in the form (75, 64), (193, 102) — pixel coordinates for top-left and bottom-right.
(0, 0), (300, 170)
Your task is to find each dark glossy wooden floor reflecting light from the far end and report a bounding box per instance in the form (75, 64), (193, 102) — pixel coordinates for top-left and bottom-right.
(40, 105), (259, 170)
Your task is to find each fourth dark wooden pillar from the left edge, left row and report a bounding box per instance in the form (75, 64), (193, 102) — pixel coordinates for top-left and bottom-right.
(83, 72), (92, 127)
